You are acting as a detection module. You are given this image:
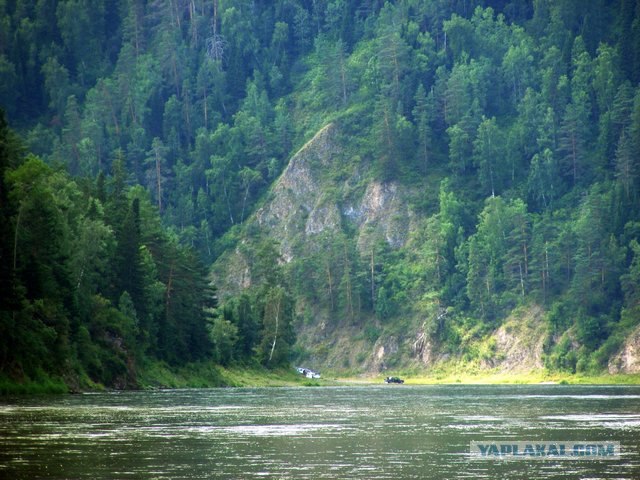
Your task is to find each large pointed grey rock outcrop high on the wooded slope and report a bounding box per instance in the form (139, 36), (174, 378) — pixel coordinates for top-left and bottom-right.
(212, 124), (413, 297)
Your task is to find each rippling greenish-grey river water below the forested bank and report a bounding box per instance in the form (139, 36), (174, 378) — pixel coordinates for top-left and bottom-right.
(0, 385), (640, 480)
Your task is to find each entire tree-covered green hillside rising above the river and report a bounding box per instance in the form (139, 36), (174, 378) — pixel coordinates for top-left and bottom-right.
(0, 0), (640, 385)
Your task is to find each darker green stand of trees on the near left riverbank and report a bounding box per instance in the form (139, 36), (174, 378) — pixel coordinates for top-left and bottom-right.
(0, 111), (215, 389)
